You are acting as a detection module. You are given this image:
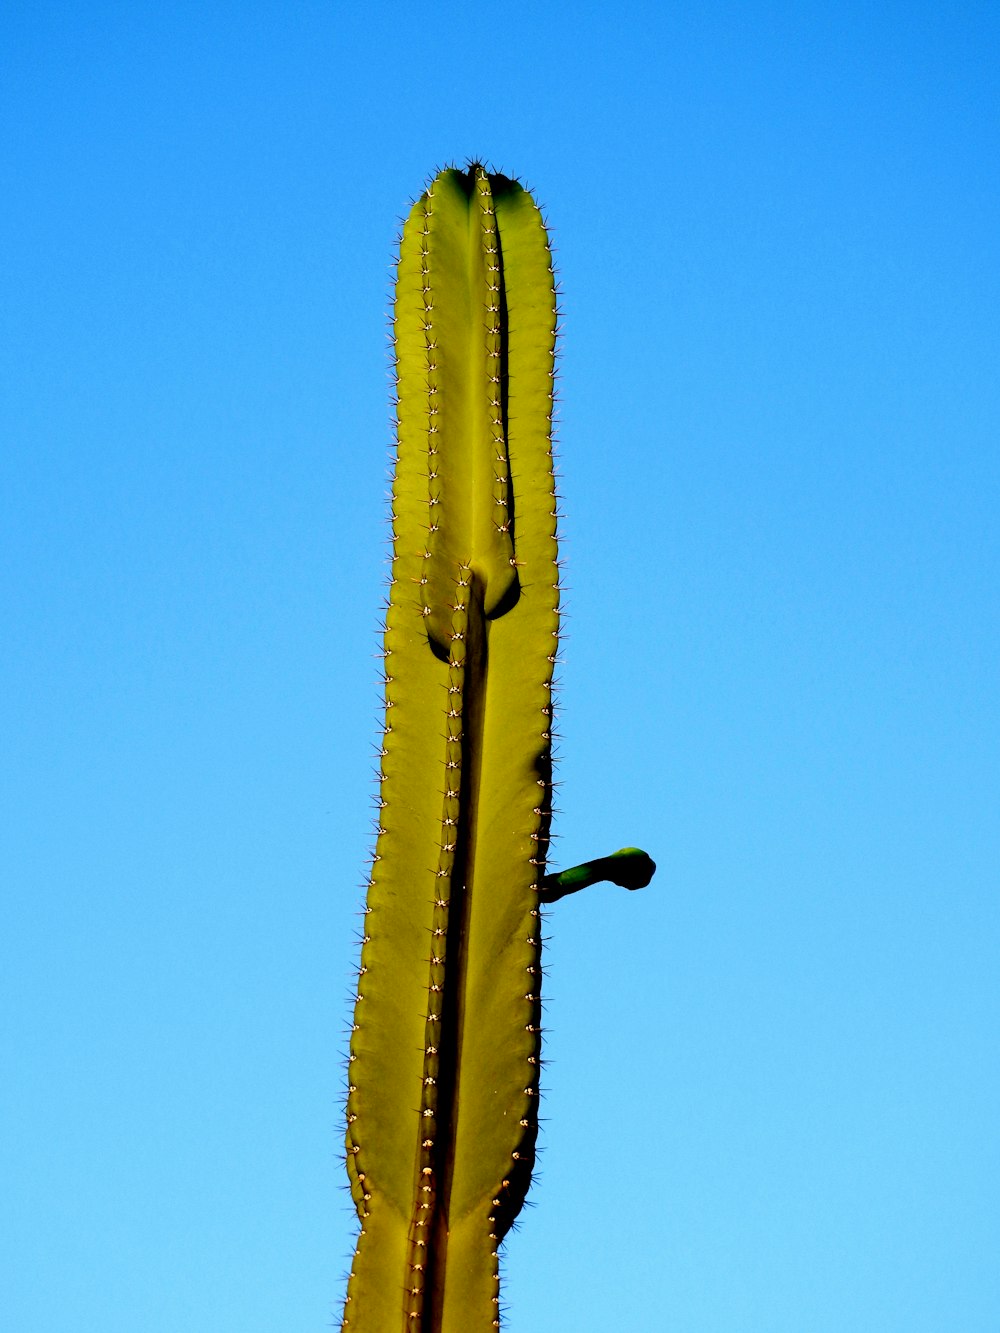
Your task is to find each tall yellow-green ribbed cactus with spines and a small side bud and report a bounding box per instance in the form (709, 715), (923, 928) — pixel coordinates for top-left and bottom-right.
(343, 164), (652, 1333)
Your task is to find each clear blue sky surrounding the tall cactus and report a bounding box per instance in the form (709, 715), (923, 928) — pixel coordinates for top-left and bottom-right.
(0, 0), (1000, 1333)
